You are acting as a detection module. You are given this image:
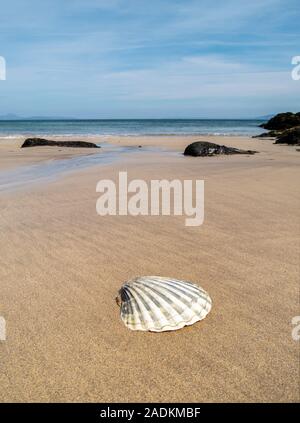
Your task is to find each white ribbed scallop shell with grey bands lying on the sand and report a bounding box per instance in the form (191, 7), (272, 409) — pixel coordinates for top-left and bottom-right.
(117, 276), (212, 332)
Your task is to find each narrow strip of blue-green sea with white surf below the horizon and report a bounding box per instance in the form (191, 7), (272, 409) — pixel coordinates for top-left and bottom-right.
(0, 119), (263, 139)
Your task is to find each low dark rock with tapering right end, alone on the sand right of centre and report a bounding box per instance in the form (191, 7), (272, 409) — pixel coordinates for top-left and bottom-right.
(183, 141), (257, 156)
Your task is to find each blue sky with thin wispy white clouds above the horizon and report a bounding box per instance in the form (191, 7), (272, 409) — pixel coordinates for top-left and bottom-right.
(0, 0), (300, 118)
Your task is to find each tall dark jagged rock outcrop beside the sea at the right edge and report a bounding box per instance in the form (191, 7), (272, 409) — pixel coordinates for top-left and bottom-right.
(254, 112), (300, 145)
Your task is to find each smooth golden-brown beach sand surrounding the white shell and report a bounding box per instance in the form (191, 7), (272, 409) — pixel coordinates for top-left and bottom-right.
(0, 137), (300, 402)
